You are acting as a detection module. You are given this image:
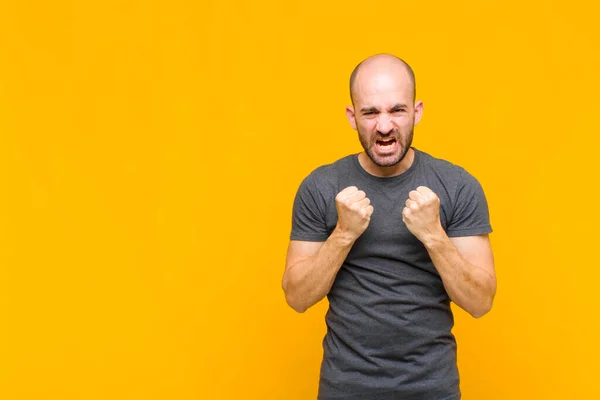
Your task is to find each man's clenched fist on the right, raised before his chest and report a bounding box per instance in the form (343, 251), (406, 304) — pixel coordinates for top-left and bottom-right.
(402, 186), (443, 242)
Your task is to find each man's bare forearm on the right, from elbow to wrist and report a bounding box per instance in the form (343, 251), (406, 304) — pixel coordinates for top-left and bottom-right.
(424, 232), (496, 318)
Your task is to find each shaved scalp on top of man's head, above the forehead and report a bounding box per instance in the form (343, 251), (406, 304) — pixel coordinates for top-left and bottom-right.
(350, 54), (417, 104)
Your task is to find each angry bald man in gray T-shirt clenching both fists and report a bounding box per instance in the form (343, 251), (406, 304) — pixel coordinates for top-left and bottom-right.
(282, 54), (496, 400)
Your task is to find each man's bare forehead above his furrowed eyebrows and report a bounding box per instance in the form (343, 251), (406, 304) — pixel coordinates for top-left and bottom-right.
(354, 69), (414, 106)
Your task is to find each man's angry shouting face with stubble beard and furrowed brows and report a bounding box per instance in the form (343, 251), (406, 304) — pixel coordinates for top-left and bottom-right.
(347, 71), (422, 167)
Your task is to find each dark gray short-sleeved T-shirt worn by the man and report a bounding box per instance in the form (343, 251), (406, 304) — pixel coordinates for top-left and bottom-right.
(291, 147), (492, 400)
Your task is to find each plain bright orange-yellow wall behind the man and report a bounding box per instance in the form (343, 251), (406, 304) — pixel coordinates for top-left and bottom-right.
(0, 0), (600, 400)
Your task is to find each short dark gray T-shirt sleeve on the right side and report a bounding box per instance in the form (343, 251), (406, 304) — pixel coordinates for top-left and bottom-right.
(447, 168), (492, 237)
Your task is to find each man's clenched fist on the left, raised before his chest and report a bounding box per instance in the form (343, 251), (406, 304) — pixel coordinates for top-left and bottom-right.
(335, 186), (373, 240)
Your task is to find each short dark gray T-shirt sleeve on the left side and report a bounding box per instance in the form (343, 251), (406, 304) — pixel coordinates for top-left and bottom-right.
(290, 173), (329, 242)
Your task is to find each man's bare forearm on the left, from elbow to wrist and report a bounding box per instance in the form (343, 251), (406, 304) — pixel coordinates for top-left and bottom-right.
(282, 229), (354, 312)
